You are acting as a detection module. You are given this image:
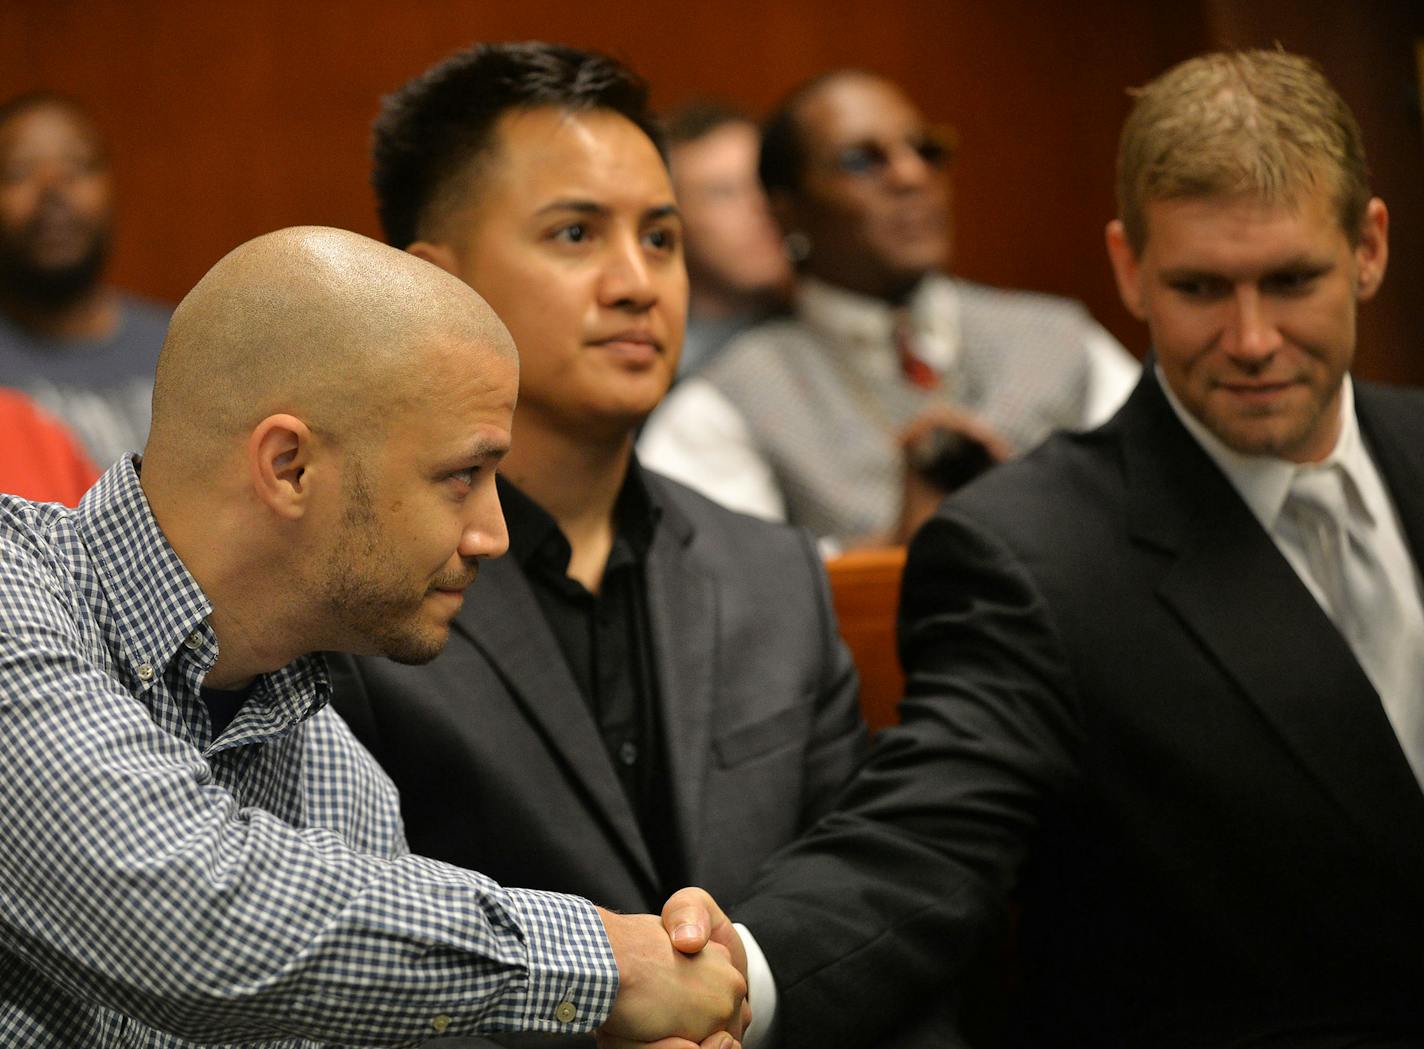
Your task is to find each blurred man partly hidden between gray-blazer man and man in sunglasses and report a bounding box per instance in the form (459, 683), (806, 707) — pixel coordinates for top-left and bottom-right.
(665, 102), (792, 376)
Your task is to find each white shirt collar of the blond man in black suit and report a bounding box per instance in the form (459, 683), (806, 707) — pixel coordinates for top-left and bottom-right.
(1156, 364), (1376, 531)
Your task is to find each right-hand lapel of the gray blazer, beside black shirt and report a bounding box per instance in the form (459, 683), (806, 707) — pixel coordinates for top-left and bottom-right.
(644, 474), (718, 880)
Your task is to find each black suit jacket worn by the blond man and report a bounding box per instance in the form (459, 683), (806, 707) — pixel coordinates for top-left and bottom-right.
(735, 367), (1424, 1046)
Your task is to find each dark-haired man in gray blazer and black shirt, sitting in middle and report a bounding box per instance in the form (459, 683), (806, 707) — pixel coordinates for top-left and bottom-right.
(336, 44), (866, 1047)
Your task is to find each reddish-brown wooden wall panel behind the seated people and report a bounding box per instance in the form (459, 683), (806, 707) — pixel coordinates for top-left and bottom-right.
(0, 0), (1424, 383)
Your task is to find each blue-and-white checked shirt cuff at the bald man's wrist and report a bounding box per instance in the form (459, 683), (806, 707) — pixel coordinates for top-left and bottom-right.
(504, 888), (618, 1035)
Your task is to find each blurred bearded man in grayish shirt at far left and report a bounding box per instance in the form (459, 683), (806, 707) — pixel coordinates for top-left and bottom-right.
(0, 91), (168, 467)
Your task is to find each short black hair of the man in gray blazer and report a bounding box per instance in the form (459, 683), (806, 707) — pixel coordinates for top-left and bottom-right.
(370, 41), (664, 248)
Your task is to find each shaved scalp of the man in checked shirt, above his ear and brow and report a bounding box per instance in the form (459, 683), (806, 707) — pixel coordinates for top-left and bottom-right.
(145, 226), (514, 468)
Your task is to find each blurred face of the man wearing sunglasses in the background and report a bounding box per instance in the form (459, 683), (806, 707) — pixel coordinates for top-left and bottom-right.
(775, 73), (951, 300)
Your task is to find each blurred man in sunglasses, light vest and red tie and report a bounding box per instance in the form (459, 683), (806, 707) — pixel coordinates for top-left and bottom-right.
(641, 70), (1139, 548)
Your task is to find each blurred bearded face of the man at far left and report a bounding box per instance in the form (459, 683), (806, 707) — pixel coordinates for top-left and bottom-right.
(0, 102), (112, 302)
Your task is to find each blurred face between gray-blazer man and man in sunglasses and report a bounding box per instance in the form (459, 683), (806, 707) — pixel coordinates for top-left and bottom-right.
(669, 121), (790, 306)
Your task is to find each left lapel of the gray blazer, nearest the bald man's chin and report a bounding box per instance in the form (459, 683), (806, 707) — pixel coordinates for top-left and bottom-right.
(453, 558), (658, 887)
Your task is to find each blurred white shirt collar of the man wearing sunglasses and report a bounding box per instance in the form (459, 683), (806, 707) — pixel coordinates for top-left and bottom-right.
(796, 273), (960, 371)
